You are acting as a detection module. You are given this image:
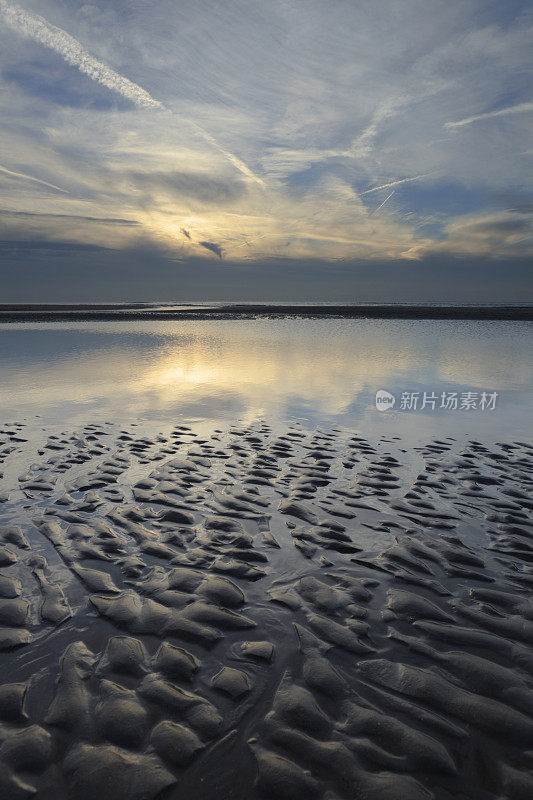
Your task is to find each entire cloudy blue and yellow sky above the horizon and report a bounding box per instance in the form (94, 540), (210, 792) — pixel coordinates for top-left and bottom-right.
(0, 0), (533, 302)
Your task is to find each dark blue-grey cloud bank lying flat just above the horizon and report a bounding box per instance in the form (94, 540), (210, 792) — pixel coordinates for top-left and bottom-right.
(0, 241), (532, 303)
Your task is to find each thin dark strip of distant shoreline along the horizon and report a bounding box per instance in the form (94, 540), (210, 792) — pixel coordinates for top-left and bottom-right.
(0, 303), (533, 322)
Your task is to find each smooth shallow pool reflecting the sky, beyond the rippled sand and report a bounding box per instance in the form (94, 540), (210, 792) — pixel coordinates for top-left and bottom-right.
(0, 319), (532, 436)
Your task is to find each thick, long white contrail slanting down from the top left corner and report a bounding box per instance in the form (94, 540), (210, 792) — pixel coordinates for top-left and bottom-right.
(0, 0), (265, 188)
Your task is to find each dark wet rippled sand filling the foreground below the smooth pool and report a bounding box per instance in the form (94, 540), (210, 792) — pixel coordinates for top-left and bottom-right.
(0, 422), (533, 800)
